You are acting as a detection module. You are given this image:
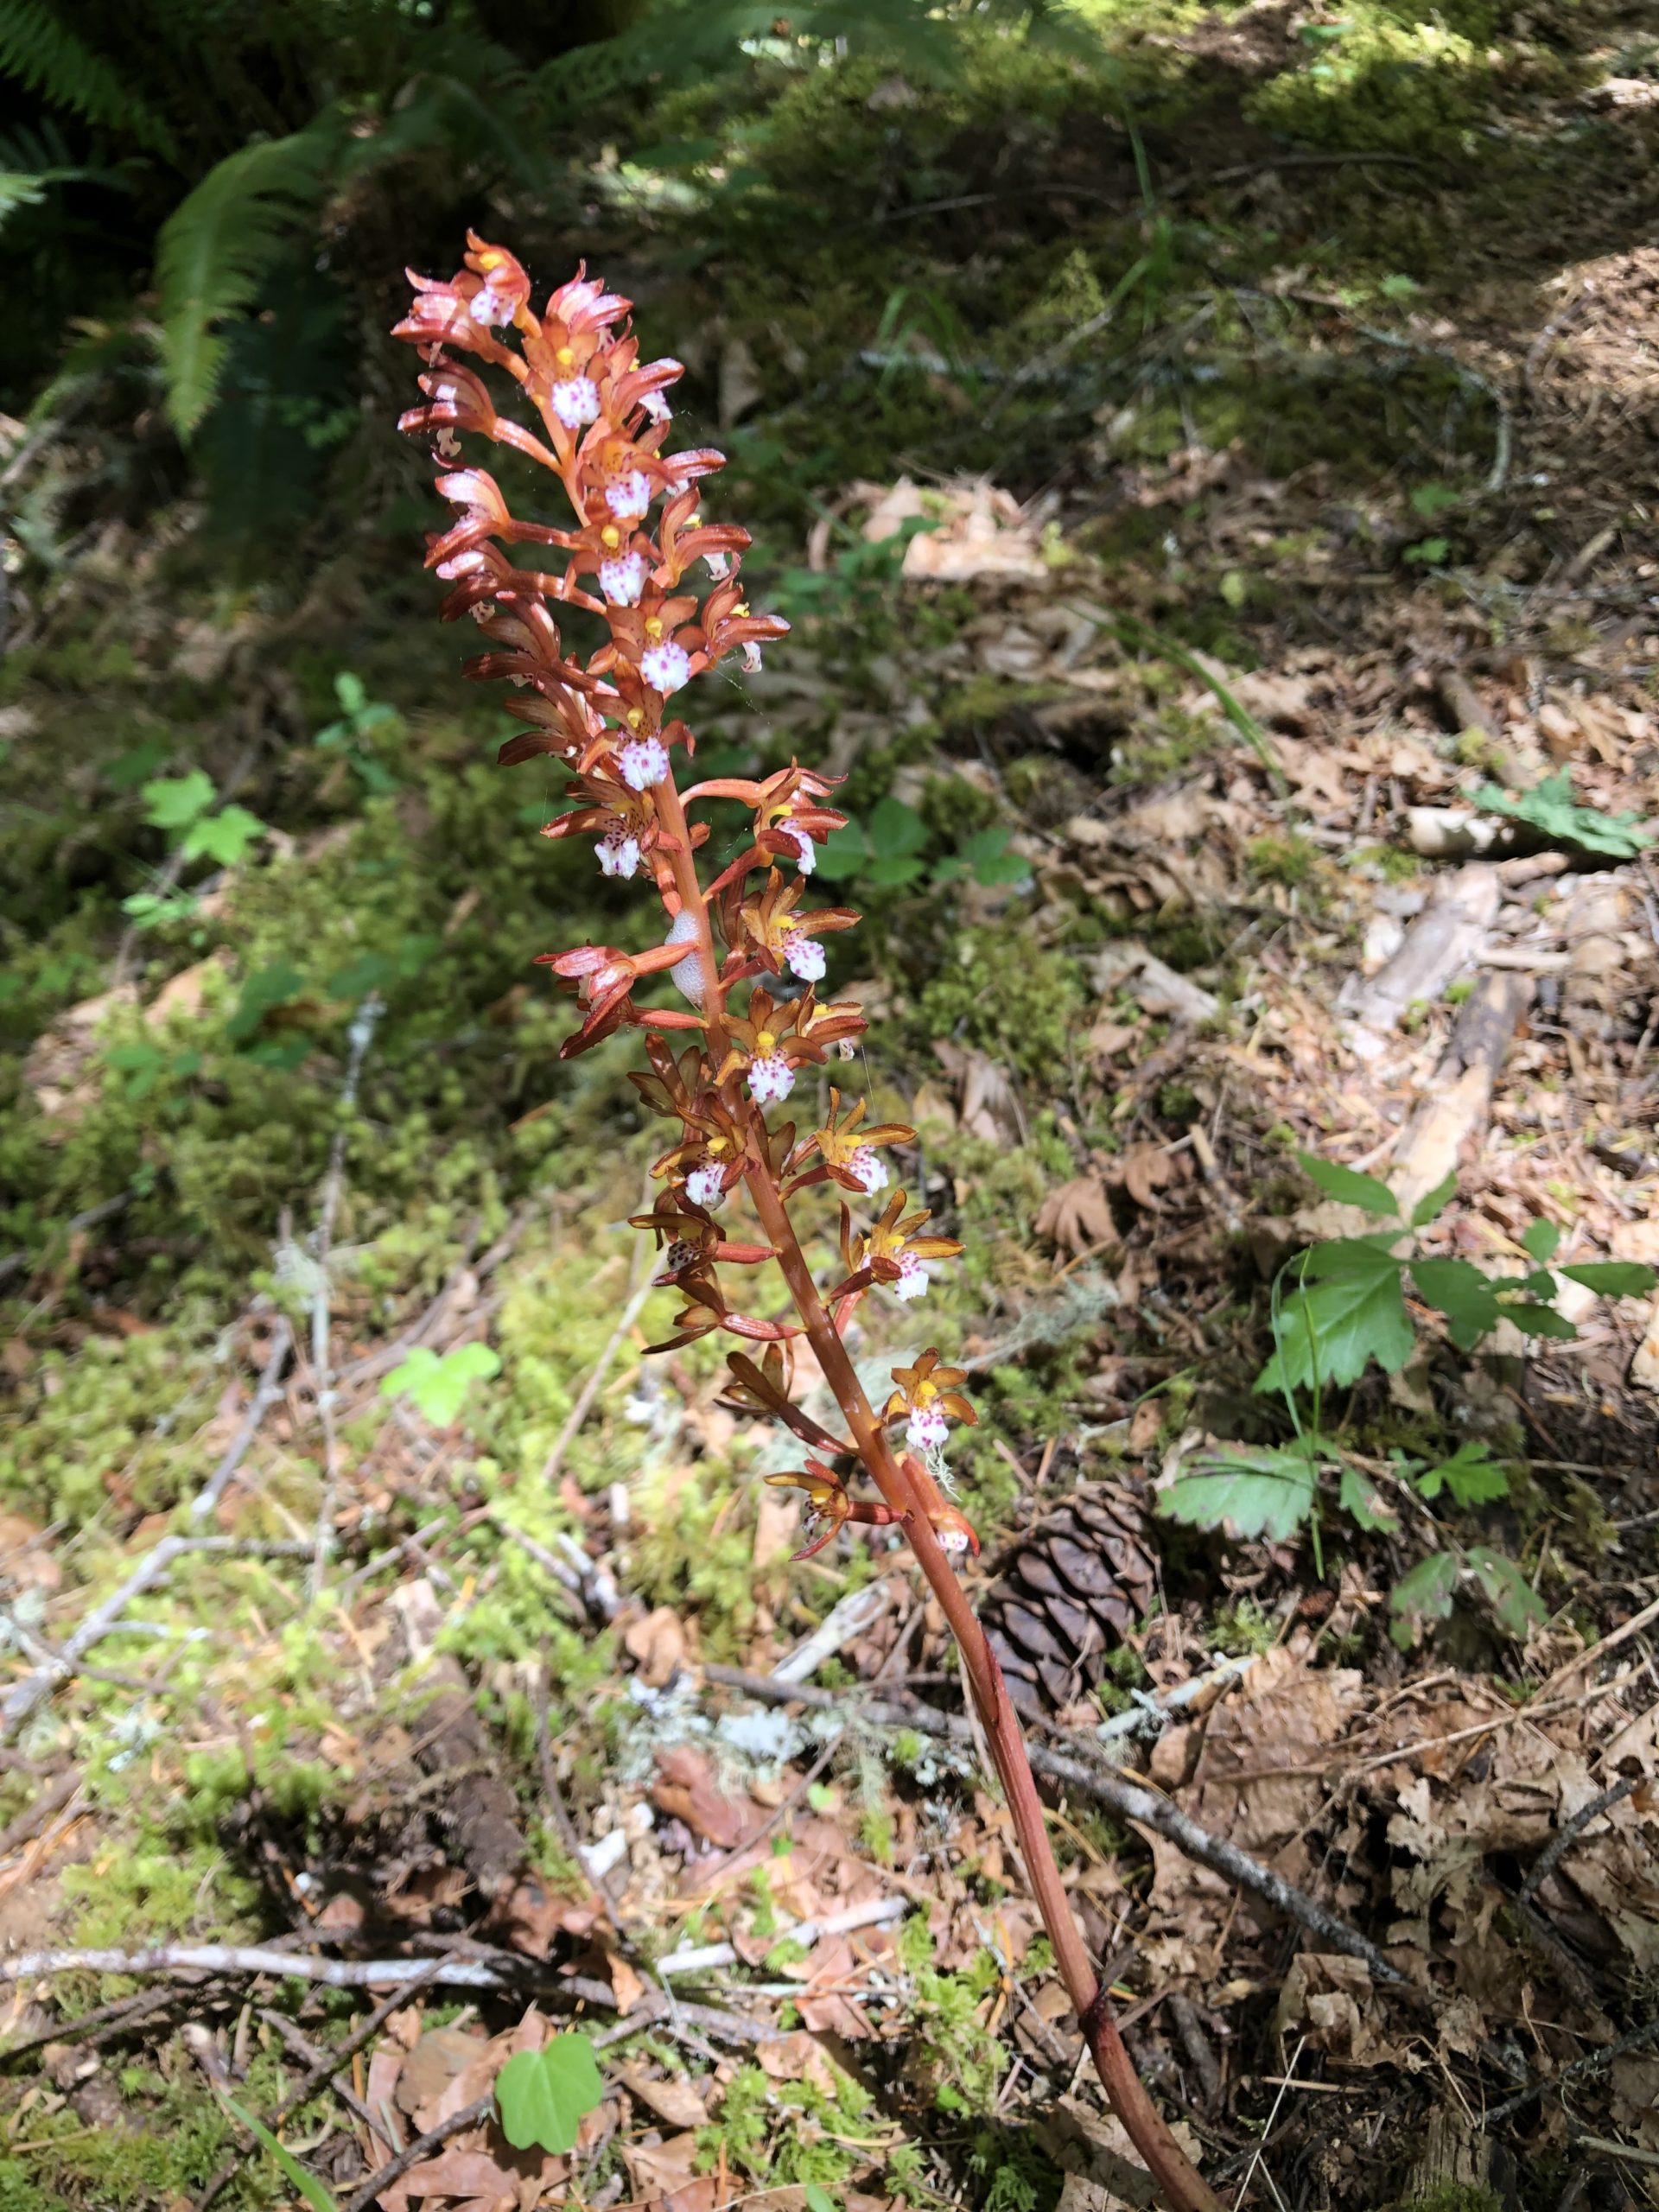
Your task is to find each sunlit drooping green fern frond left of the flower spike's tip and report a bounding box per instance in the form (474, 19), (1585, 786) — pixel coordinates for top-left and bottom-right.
(155, 127), (340, 438)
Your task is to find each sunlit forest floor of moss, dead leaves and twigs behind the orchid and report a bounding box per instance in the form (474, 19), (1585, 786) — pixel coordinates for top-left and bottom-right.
(0, 4), (1659, 2212)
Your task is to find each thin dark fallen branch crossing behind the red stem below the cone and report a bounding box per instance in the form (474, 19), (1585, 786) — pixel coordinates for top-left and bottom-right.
(703, 1666), (1405, 1984)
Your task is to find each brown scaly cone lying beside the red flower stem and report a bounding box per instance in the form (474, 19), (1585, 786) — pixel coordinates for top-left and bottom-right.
(980, 1482), (1157, 1712)
